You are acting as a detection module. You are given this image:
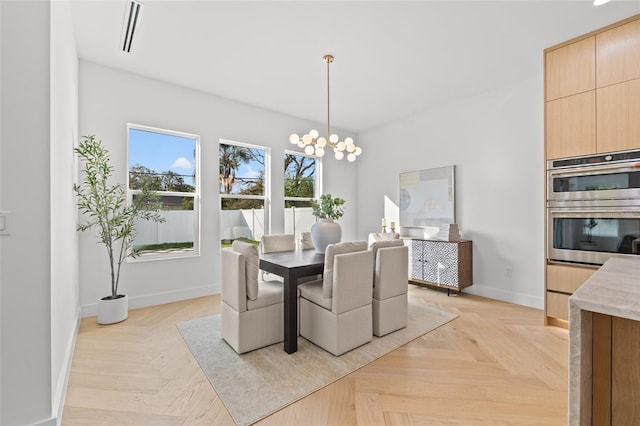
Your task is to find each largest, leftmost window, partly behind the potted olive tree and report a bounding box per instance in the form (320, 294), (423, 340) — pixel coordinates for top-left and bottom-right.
(127, 124), (200, 260)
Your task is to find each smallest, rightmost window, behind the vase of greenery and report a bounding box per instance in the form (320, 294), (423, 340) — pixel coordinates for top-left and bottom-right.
(284, 152), (320, 235)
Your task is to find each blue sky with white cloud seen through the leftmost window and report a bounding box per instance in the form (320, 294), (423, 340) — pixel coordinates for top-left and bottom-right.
(129, 128), (196, 185)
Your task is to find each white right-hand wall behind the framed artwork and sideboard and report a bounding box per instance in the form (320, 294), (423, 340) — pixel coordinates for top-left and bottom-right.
(358, 73), (544, 308)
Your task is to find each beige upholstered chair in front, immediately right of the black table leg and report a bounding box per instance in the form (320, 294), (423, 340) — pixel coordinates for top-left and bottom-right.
(298, 241), (373, 356)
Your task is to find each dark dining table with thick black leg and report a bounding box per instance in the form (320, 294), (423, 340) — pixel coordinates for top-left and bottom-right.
(260, 249), (324, 354)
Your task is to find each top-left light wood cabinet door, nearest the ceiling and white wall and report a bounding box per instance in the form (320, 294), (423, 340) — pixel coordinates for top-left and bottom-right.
(545, 37), (596, 101)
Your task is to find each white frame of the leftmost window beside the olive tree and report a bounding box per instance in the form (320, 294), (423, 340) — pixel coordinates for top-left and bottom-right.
(126, 123), (202, 263)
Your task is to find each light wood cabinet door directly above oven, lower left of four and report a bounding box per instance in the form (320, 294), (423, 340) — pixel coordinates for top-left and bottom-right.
(546, 90), (596, 159)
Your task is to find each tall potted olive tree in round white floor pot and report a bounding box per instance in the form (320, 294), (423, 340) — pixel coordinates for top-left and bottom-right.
(73, 135), (165, 324)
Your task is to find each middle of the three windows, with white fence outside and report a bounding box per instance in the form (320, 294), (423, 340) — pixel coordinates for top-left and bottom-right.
(218, 141), (269, 247)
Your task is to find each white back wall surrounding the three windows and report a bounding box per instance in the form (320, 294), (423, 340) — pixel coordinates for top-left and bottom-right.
(79, 60), (357, 316)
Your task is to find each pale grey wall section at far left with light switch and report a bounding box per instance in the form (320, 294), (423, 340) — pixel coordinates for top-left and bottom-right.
(0, 1), (55, 425)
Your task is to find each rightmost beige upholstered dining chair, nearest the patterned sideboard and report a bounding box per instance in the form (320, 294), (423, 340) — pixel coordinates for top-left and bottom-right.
(369, 239), (409, 336)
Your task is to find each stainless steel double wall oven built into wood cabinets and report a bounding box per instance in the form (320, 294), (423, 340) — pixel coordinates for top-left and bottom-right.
(547, 151), (640, 266)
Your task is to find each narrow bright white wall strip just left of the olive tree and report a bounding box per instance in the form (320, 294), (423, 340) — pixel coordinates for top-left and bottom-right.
(50, 0), (80, 421)
